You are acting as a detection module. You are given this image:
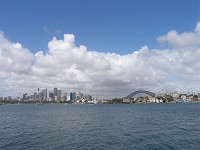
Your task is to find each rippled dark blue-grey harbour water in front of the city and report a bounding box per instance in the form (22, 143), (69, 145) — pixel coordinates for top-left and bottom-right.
(0, 103), (200, 150)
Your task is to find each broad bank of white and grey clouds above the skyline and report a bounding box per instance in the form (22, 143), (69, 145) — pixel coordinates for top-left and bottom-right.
(0, 23), (200, 98)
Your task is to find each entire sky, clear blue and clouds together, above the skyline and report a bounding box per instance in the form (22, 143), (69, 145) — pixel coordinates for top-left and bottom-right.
(0, 0), (200, 98)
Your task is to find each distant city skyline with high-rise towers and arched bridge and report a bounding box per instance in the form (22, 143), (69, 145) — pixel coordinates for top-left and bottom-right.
(0, 87), (200, 102)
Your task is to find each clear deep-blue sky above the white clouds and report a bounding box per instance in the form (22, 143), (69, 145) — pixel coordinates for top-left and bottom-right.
(0, 0), (200, 54)
